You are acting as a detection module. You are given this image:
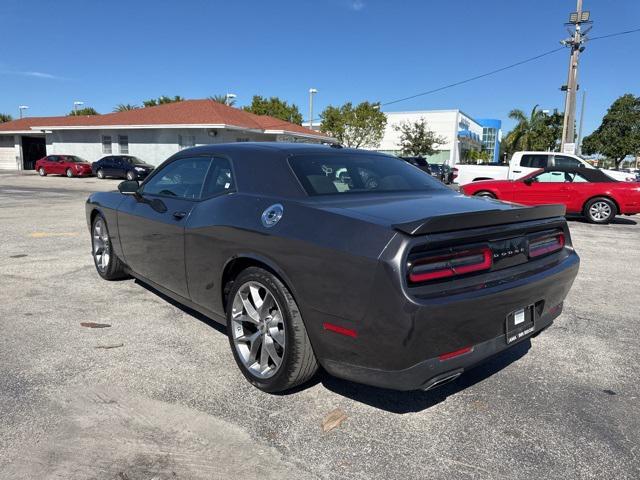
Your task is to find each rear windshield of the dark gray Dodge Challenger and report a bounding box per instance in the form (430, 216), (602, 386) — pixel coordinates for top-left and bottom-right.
(289, 154), (446, 195)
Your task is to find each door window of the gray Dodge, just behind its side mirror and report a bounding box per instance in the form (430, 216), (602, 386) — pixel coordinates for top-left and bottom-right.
(142, 157), (211, 200)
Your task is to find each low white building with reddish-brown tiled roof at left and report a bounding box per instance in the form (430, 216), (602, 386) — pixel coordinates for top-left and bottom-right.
(0, 100), (334, 170)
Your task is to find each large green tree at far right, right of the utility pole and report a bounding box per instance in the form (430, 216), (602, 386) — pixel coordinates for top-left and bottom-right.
(582, 93), (640, 169)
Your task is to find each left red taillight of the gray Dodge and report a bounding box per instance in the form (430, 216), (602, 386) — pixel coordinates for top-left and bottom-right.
(409, 247), (493, 283)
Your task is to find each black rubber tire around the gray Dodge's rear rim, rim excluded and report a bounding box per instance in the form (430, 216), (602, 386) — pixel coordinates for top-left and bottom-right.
(227, 267), (318, 393)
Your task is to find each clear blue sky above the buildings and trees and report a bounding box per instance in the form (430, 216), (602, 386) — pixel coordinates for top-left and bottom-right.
(0, 0), (640, 133)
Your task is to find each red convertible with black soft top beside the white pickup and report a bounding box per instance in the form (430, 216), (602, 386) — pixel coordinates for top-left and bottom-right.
(462, 167), (640, 223)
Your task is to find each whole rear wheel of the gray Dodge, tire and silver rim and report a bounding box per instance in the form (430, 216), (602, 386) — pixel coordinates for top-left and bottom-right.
(227, 267), (318, 392)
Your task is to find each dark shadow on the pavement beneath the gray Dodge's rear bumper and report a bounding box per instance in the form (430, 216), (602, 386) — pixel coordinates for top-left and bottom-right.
(320, 339), (531, 414)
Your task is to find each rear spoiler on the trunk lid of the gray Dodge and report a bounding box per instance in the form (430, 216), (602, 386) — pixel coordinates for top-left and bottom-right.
(393, 205), (566, 235)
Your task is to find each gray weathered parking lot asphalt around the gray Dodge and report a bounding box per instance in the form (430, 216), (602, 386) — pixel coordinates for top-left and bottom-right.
(0, 173), (640, 480)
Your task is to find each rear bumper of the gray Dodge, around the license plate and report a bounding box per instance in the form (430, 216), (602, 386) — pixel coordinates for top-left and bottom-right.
(312, 250), (580, 390)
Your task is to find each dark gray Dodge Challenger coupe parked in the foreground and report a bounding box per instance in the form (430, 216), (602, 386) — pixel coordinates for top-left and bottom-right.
(86, 143), (580, 392)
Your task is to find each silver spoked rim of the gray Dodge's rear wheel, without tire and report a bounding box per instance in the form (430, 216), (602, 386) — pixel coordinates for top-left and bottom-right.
(231, 281), (285, 379)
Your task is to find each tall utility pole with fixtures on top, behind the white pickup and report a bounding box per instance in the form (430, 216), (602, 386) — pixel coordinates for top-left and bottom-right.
(560, 0), (591, 153)
